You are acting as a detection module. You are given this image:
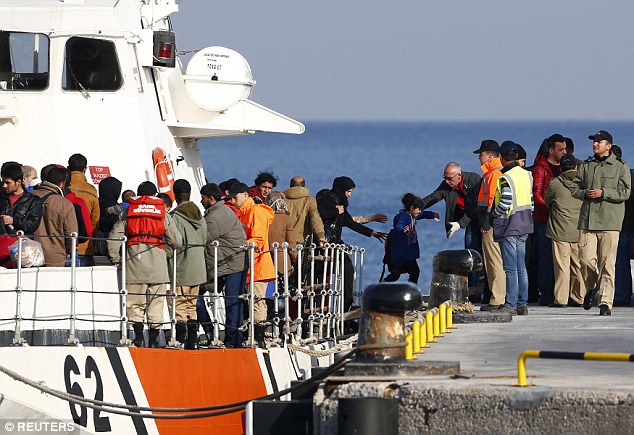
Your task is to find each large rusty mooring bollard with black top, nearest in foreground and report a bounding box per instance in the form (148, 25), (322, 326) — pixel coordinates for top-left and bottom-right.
(344, 283), (460, 377)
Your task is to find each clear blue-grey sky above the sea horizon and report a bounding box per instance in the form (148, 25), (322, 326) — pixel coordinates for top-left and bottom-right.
(172, 0), (634, 121)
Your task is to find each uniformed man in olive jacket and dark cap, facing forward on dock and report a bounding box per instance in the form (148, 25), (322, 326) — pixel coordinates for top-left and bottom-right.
(572, 130), (631, 316)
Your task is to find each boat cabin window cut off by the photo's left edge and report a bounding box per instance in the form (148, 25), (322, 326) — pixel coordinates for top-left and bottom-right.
(0, 30), (50, 91)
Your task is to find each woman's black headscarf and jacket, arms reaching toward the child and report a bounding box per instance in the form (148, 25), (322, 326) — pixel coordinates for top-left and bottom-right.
(317, 177), (372, 243)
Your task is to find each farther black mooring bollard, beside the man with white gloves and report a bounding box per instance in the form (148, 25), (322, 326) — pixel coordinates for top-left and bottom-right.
(429, 249), (482, 307)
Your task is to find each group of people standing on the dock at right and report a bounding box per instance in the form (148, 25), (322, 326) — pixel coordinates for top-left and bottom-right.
(402, 130), (634, 316)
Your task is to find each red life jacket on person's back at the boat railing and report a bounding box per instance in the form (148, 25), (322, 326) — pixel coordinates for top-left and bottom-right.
(125, 196), (165, 249)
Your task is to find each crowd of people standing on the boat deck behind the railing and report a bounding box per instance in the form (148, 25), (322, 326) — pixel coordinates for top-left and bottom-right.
(0, 154), (387, 349)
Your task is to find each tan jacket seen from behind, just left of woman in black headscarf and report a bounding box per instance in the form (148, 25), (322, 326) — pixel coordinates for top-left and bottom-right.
(284, 186), (324, 244)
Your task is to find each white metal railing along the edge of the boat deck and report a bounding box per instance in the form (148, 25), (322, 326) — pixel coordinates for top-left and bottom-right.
(0, 231), (365, 347)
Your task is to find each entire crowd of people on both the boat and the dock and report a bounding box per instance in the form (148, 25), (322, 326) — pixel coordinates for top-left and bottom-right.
(0, 130), (634, 349)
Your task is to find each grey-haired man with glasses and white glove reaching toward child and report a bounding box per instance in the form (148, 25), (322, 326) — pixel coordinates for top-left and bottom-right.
(422, 162), (482, 286)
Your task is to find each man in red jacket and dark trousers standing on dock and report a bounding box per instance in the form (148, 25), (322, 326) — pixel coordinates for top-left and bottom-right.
(532, 134), (566, 306)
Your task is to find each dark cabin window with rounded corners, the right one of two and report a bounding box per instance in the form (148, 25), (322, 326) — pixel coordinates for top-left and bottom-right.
(62, 37), (123, 91)
